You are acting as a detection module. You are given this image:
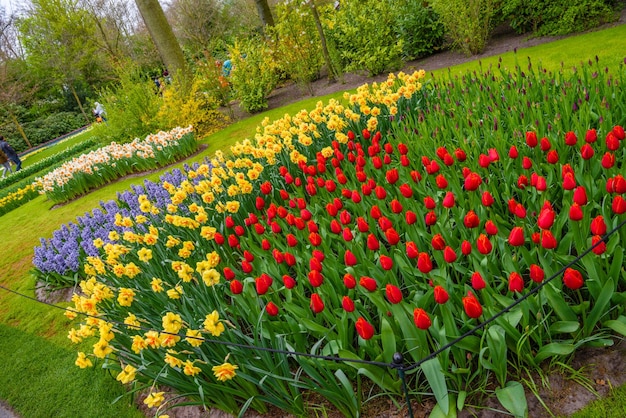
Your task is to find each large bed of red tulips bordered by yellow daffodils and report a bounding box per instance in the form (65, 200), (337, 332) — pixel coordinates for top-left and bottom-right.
(33, 60), (626, 416)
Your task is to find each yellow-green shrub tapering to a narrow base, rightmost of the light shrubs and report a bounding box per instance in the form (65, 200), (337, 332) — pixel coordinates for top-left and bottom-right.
(431, 0), (496, 56)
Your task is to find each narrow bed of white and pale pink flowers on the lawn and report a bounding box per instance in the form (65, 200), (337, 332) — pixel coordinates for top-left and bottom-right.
(36, 127), (197, 203)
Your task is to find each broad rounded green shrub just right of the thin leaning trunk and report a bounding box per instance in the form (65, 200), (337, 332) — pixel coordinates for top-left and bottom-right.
(326, 0), (403, 75)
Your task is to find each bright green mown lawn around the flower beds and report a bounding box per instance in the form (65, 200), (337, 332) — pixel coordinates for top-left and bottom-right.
(0, 25), (626, 418)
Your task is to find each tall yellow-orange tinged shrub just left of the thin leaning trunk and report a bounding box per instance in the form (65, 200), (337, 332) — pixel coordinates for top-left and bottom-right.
(269, 2), (322, 91)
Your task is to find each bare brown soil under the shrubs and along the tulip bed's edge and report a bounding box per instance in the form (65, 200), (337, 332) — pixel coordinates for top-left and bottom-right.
(28, 9), (626, 418)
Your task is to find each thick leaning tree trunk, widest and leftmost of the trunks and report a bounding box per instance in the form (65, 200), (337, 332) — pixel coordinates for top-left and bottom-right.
(135, 0), (187, 78)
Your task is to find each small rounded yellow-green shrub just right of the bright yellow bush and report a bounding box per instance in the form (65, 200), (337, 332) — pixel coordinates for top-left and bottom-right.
(229, 38), (278, 113)
